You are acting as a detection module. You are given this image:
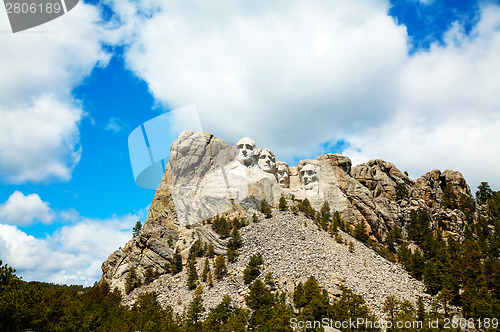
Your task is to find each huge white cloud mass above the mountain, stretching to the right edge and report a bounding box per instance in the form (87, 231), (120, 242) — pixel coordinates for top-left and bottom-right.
(108, 0), (500, 188)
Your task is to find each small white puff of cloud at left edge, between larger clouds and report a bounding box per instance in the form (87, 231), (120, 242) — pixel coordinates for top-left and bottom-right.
(0, 191), (54, 226)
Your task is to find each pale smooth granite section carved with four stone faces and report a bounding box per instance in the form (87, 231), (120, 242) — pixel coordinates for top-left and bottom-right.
(165, 132), (350, 226)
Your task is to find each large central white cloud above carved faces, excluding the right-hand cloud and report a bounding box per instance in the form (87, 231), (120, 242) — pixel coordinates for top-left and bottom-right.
(107, 0), (407, 159)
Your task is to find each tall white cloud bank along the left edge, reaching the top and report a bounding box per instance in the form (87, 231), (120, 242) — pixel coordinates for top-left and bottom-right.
(0, 2), (108, 183)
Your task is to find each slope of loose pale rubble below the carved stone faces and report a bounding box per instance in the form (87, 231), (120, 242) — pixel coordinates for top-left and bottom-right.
(124, 210), (431, 317)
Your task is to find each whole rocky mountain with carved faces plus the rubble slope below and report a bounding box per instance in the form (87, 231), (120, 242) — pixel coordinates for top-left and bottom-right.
(102, 132), (478, 311)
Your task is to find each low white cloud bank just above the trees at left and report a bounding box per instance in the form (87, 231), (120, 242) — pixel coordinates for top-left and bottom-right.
(0, 215), (139, 286)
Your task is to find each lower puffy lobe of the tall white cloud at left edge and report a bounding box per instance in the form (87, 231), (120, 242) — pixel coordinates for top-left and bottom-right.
(0, 96), (82, 183)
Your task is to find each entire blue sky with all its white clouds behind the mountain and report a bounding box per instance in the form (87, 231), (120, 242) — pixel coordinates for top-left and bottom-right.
(0, 0), (500, 285)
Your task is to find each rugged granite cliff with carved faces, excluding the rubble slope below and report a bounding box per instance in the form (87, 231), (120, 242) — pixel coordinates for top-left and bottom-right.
(102, 132), (477, 296)
